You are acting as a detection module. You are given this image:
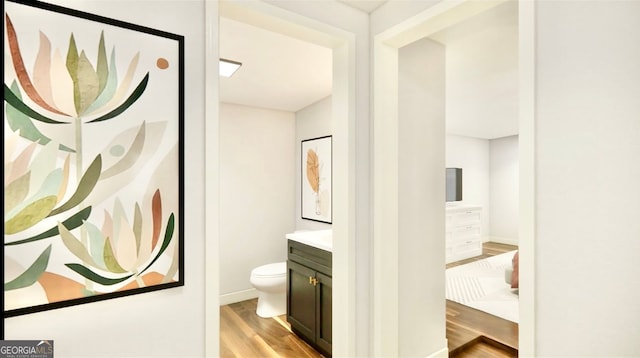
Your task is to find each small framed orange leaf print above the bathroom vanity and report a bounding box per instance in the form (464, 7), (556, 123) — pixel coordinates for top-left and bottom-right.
(301, 136), (332, 224)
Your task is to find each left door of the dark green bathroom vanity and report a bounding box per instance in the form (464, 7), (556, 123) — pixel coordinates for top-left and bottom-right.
(287, 260), (316, 342)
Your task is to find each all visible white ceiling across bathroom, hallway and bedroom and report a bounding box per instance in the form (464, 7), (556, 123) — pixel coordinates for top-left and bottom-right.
(220, 0), (518, 139)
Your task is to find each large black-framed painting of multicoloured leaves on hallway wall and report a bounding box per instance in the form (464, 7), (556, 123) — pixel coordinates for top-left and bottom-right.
(3, 0), (184, 317)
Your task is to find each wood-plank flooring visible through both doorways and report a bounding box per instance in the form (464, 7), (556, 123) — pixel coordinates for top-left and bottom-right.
(220, 243), (518, 358)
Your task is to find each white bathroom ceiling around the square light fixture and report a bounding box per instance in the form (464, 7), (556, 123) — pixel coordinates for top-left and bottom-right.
(220, 18), (332, 112)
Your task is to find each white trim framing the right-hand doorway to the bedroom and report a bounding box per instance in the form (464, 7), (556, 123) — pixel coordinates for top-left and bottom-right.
(372, 0), (536, 356)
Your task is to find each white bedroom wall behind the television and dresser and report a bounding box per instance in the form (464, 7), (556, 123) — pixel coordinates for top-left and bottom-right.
(443, 135), (492, 241)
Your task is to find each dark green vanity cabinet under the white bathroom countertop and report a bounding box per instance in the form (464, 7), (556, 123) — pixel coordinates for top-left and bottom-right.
(287, 240), (331, 356)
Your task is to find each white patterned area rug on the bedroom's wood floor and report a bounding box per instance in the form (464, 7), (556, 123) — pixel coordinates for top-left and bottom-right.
(446, 251), (519, 323)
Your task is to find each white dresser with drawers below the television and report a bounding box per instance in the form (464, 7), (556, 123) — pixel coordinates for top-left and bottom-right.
(445, 205), (482, 263)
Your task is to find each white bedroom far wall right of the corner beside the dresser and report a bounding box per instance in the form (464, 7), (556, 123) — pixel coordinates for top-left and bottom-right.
(489, 136), (520, 245)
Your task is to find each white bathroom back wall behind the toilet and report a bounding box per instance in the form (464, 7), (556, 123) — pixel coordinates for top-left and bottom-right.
(220, 103), (296, 304)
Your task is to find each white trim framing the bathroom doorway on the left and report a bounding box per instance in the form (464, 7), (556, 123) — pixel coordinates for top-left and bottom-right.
(205, 1), (356, 356)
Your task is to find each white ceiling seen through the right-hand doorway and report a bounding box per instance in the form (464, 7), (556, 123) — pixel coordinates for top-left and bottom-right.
(440, 1), (518, 139)
